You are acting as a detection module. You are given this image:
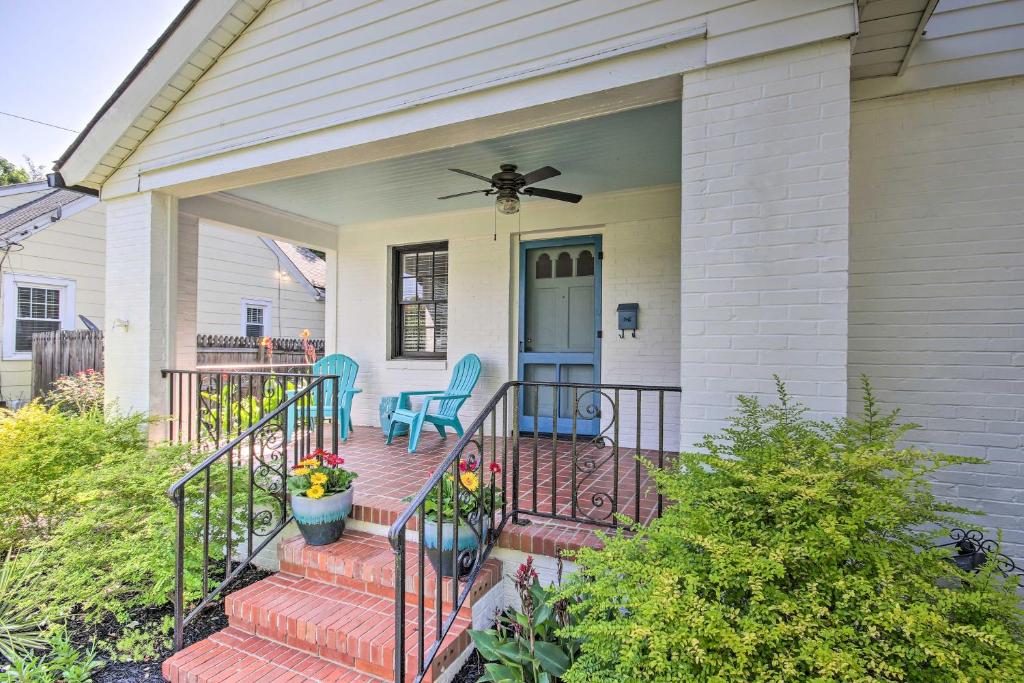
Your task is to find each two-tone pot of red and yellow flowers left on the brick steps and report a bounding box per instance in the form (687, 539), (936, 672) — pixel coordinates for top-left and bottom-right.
(288, 449), (357, 546)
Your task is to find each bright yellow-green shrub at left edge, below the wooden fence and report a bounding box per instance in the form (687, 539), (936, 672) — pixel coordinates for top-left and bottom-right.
(0, 402), (146, 550)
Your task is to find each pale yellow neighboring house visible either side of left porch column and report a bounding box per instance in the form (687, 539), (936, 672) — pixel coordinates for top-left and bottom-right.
(0, 181), (325, 400)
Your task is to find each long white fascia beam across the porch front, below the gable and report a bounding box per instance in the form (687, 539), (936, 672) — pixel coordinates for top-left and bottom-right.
(103, 30), (706, 199)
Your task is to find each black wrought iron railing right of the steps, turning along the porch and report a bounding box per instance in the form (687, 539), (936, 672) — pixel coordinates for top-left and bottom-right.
(388, 381), (680, 681)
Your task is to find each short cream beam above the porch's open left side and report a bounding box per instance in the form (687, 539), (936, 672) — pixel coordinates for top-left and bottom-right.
(178, 193), (338, 250)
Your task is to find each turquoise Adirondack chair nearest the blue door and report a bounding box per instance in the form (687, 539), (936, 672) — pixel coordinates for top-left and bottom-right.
(387, 353), (480, 453)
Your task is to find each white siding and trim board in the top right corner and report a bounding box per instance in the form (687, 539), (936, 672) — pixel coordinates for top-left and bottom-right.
(854, 0), (1024, 99)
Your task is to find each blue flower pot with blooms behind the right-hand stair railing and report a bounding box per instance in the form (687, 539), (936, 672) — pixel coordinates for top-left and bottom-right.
(411, 460), (502, 579)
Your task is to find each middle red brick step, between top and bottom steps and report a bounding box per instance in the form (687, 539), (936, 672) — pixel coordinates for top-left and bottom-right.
(224, 571), (471, 679)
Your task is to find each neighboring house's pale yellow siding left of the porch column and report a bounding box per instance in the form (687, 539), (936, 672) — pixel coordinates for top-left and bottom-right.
(0, 200), (105, 399)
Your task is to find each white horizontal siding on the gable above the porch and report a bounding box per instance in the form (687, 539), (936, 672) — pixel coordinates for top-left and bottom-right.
(105, 0), (855, 189)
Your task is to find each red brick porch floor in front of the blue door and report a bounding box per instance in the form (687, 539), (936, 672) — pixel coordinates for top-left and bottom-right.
(325, 427), (671, 556)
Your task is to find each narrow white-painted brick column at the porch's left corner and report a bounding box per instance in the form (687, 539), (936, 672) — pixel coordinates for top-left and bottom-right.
(104, 193), (196, 437)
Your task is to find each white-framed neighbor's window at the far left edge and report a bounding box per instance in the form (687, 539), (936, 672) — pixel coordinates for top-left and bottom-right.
(3, 272), (75, 360)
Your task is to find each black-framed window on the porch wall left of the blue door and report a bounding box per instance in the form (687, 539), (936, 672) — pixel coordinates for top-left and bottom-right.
(392, 242), (449, 358)
